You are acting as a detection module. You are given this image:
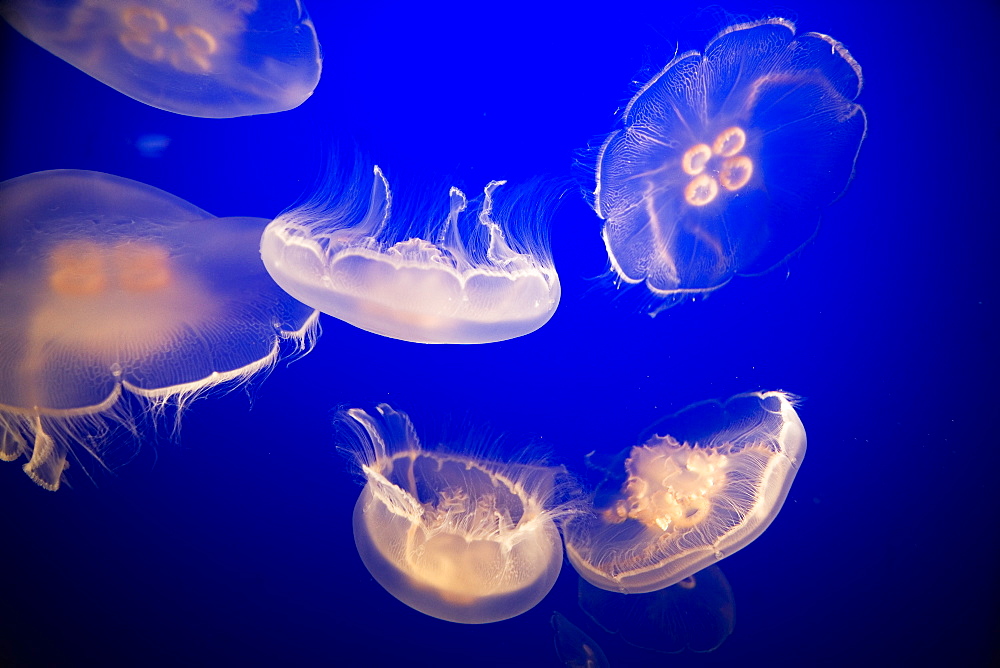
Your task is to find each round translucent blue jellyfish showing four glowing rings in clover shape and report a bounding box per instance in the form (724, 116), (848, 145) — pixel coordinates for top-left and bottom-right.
(594, 18), (867, 315)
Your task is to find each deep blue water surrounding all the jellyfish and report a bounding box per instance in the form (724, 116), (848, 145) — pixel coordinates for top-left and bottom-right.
(0, 0), (1000, 666)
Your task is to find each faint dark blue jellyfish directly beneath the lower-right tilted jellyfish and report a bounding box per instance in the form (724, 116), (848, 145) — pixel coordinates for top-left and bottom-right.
(579, 566), (735, 654)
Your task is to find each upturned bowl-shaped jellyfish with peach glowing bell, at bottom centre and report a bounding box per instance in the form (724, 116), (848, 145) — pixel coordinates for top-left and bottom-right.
(338, 404), (564, 624)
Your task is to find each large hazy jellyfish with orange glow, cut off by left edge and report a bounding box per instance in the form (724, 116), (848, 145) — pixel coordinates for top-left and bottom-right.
(0, 170), (318, 490)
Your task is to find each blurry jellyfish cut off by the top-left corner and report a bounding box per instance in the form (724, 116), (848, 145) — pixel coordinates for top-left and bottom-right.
(0, 0), (322, 118)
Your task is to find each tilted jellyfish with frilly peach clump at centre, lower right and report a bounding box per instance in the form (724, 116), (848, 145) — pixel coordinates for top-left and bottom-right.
(563, 392), (806, 594)
